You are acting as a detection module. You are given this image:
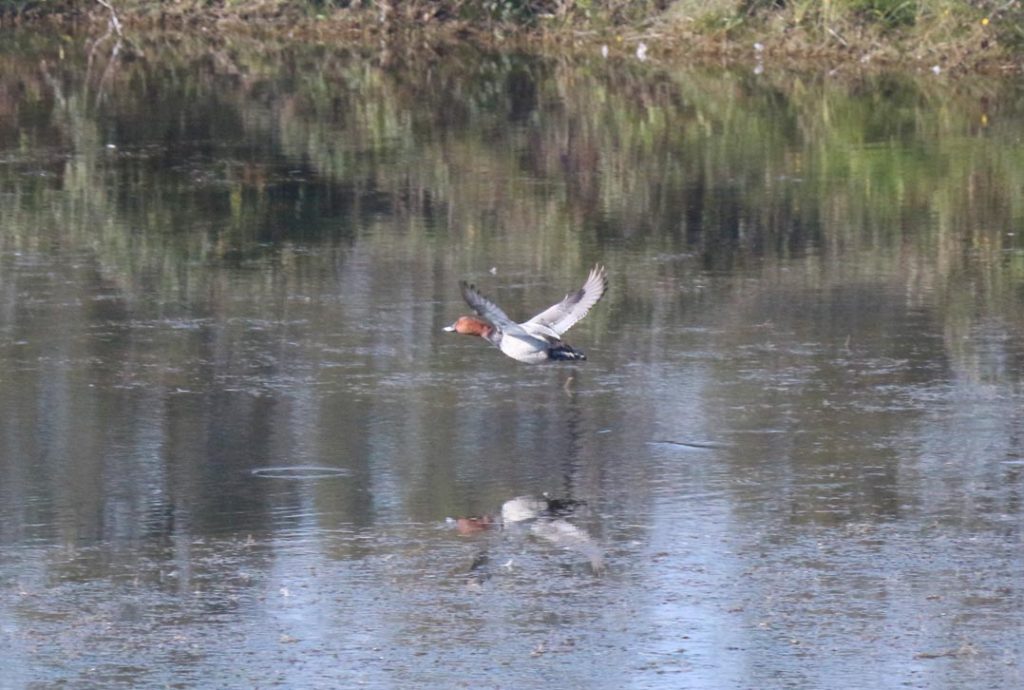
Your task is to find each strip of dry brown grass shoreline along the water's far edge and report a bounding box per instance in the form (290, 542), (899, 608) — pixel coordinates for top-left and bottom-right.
(0, 0), (1024, 76)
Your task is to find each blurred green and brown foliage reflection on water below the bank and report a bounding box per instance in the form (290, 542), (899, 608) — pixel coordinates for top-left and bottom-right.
(0, 29), (1024, 323)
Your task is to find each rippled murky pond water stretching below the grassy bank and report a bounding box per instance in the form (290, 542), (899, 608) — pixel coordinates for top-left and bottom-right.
(0, 34), (1024, 688)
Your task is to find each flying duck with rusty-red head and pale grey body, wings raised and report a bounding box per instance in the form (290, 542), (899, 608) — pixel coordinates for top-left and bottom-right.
(444, 266), (608, 364)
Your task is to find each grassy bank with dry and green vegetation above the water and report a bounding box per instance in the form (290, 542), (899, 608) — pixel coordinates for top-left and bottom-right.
(0, 0), (1024, 74)
